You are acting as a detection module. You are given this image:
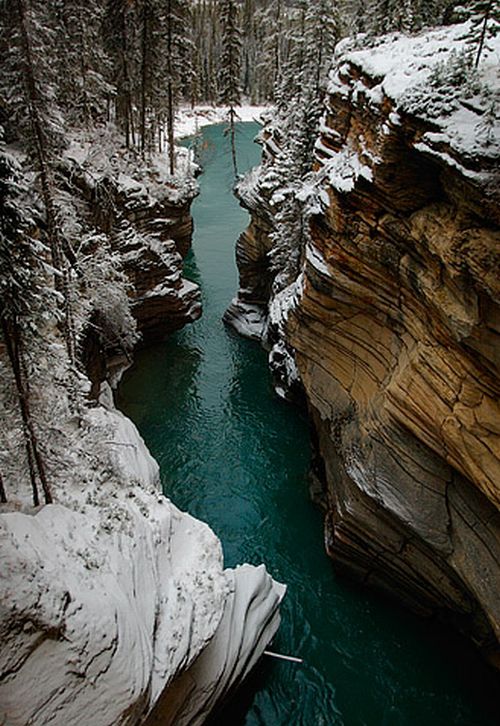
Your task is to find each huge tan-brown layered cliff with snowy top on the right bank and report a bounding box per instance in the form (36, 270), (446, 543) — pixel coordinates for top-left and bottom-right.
(229, 28), (500, 665)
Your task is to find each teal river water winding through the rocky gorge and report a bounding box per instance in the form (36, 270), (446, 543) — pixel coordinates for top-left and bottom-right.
(119, 124), (498, 726)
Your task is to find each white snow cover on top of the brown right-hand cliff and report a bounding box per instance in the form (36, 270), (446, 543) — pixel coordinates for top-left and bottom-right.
(328, 23), (500, 162)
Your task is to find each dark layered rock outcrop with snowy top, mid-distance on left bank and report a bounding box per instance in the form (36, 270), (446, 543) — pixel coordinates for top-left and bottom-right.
(62, 143), (201, 344)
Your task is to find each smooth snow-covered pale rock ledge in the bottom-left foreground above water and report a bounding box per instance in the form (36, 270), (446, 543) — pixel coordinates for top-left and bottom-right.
(0, 406), (285, 726)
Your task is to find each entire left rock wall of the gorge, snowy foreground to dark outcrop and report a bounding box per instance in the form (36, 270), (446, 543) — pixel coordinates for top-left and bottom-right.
(0, 128), (286, 726)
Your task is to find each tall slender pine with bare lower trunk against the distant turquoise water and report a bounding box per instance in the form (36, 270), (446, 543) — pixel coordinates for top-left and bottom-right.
(219, 0), (241, 176)
